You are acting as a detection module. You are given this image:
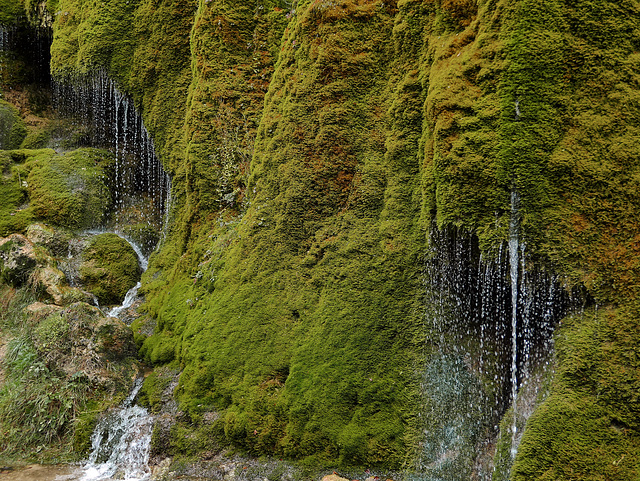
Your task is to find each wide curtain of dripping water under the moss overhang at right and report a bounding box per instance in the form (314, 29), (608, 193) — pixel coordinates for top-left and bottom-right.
(418, 226), (573, 481)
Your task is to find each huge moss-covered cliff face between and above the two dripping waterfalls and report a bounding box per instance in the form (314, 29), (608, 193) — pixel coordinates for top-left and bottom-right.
(42, 0), (640, 472)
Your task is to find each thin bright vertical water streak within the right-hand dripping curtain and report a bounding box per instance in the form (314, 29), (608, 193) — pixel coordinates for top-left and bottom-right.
(509, 190), (520, 457)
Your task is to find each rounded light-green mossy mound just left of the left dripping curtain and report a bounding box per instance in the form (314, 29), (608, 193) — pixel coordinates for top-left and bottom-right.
(26, 149), (111, 229)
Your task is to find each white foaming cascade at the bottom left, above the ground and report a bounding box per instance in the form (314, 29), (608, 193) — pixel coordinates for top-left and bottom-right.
(81, 379), (153, 481)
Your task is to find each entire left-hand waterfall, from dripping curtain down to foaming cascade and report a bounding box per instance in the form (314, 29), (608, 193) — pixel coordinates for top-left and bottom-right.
(47, 72), (165, 481)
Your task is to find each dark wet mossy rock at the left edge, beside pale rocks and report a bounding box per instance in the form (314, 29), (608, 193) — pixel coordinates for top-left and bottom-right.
(0, 234), (38, 287)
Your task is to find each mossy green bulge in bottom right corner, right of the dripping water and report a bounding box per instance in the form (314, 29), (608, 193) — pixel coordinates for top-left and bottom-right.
(511, 309), (640, 480)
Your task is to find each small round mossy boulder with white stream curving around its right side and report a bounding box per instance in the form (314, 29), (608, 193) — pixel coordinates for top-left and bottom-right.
(80, 234), (141, 304)
